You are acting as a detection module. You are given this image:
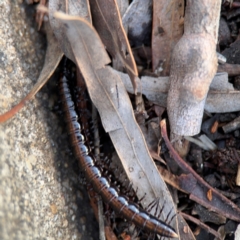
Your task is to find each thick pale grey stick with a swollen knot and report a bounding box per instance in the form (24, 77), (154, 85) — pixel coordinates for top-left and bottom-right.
(167, 0), (221, 136)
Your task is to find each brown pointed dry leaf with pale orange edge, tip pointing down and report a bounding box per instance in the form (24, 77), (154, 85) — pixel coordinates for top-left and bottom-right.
(90, 0), (138, 93)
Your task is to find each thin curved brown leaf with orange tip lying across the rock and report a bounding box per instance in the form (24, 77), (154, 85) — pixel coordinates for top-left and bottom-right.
(0, 21), (63, 123)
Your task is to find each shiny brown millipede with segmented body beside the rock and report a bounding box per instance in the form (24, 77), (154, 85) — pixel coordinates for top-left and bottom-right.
(59, 60), (178, 238)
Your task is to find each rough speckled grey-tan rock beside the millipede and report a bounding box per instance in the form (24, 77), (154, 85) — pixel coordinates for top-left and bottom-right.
(0, 0), (98, 240)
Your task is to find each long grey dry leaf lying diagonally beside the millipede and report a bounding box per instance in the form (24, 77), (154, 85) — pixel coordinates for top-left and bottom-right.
(55, 13), (177, 235)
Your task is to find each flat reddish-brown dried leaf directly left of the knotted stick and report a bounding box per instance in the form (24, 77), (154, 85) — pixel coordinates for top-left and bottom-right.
(152, 0), (184, 76)
